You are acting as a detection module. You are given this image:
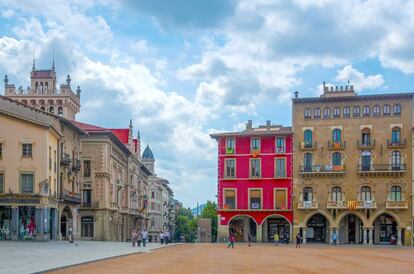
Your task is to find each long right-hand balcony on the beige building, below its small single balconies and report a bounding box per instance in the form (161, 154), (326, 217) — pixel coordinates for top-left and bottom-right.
(358, 164), (407, 177)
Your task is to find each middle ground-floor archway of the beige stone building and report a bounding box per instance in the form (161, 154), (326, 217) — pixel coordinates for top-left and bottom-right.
(338, 213), (364, 244)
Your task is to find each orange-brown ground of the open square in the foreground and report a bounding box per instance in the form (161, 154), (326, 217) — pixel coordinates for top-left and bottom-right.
(51, 244), (414, 274)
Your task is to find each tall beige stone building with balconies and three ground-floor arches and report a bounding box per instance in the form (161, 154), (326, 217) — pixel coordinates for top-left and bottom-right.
(293, 86), (413, 245)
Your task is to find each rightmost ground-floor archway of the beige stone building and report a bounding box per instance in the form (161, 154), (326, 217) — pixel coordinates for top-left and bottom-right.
(374, 213), (398, 244)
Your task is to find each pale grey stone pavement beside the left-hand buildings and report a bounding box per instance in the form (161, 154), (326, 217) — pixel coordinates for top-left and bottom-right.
(0, 241), (174, 274)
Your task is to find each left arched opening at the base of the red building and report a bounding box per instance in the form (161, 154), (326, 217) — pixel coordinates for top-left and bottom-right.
(229, 215), (257, 242)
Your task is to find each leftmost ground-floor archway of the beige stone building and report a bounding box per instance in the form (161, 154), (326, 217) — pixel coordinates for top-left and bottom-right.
(306, 213), (328, 243)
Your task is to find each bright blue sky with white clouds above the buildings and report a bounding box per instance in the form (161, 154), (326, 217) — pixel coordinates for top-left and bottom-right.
(0, 0), (414, 207)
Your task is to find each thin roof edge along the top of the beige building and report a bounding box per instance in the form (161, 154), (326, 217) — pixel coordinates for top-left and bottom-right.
(292, 92), (414, 103)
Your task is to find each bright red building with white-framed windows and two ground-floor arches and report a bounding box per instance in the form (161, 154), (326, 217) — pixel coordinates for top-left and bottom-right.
(211, 120), (293, 242)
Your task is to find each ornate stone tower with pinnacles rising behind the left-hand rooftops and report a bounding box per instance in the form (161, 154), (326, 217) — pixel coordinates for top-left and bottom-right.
(4, 60), (81, 120)
